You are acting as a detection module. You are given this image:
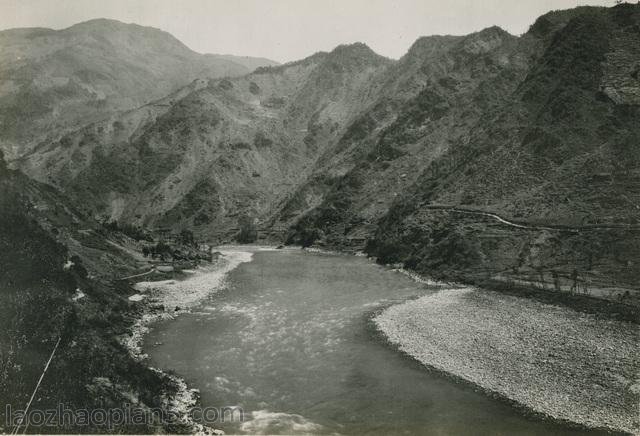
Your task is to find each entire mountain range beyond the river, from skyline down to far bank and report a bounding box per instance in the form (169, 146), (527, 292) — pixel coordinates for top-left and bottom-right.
(0, 4), (640, 296)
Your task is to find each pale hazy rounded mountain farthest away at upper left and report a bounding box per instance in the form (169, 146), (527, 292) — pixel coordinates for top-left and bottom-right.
(0, 19), (274, 160)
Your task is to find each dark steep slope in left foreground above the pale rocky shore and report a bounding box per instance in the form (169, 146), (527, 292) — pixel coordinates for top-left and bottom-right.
(0, 152), (192, 433)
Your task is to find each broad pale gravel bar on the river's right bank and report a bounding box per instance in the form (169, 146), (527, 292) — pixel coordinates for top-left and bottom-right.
(374, 288), (640, 434)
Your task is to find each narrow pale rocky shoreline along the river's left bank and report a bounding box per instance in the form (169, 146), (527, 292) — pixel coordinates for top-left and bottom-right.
(119, 246), (258, 434)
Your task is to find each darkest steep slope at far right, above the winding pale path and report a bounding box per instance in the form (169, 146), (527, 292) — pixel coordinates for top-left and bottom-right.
(421, 5), (640, 224)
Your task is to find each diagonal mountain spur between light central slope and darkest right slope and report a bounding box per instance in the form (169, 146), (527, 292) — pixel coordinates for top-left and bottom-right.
(280, 27), (536, 245)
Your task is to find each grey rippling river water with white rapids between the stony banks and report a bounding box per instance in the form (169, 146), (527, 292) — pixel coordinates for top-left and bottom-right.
(144, 250), (604, 435)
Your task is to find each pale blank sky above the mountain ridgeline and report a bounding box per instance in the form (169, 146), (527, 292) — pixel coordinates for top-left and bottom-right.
(0, 0), (615, 62)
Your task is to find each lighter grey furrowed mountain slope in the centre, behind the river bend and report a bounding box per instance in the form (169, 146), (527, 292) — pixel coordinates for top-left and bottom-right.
(20, 44), (391, 237)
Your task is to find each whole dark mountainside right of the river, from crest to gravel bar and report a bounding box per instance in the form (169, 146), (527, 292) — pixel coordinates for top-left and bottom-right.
(290, 4), (640, 299)
